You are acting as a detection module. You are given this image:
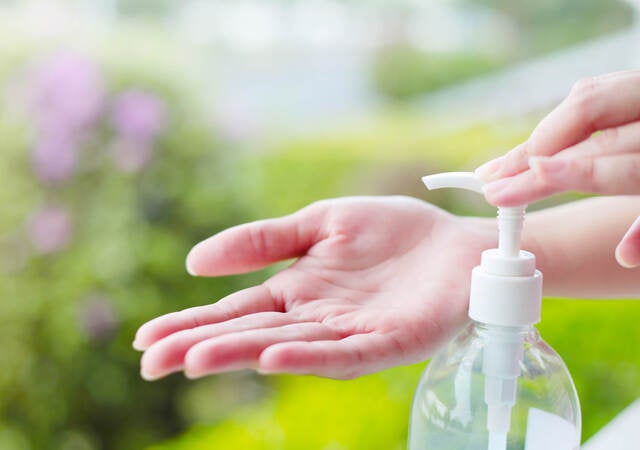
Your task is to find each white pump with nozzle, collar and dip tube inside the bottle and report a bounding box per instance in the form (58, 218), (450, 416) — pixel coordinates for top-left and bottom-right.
(422, 172), (542, 450)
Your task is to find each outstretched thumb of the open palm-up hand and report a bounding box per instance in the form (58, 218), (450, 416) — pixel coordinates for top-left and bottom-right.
(186, 202), (327, 276)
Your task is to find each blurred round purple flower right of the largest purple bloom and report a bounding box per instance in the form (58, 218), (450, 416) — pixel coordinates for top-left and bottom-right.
(111, 90), (166, 144)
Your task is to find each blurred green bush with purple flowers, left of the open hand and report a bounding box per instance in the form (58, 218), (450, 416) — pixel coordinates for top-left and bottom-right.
(0, 43), (264, 450)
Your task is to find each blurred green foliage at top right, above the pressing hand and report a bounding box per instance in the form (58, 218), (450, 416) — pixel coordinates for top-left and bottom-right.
(373, 0), (633, 100)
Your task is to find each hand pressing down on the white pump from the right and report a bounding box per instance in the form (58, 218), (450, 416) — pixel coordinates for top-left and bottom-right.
(476, 70), (640, 267)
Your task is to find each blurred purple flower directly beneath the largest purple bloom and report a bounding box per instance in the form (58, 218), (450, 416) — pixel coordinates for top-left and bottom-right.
(31, 128), (78, 184)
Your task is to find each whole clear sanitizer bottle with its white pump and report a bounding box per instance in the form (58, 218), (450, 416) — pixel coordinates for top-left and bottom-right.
(409, 172), (581, 450)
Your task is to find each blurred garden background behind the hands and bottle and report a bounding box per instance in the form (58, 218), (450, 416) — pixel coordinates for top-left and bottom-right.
(0, 0), (640, 450)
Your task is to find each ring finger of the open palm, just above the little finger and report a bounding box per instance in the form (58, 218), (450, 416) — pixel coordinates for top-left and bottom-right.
(184, 322), (344, 378)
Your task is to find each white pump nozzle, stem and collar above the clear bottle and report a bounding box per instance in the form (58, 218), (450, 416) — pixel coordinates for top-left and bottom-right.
(422, 172), (542, 326)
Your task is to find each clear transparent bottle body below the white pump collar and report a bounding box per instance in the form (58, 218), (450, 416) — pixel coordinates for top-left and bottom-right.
(409, 322), (581, 450)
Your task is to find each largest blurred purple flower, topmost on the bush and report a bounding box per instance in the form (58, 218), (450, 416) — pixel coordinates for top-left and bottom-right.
(28, 52), (105, 134)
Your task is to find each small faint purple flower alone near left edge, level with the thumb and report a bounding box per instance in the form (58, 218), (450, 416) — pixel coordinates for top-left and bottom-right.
(27, 205), (73, 254)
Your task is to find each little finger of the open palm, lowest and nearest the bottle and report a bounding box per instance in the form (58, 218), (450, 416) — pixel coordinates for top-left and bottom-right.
(259, 333), (407, 379)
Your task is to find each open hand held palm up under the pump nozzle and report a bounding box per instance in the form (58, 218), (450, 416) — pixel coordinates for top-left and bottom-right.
(134, 197), (496, 379)
